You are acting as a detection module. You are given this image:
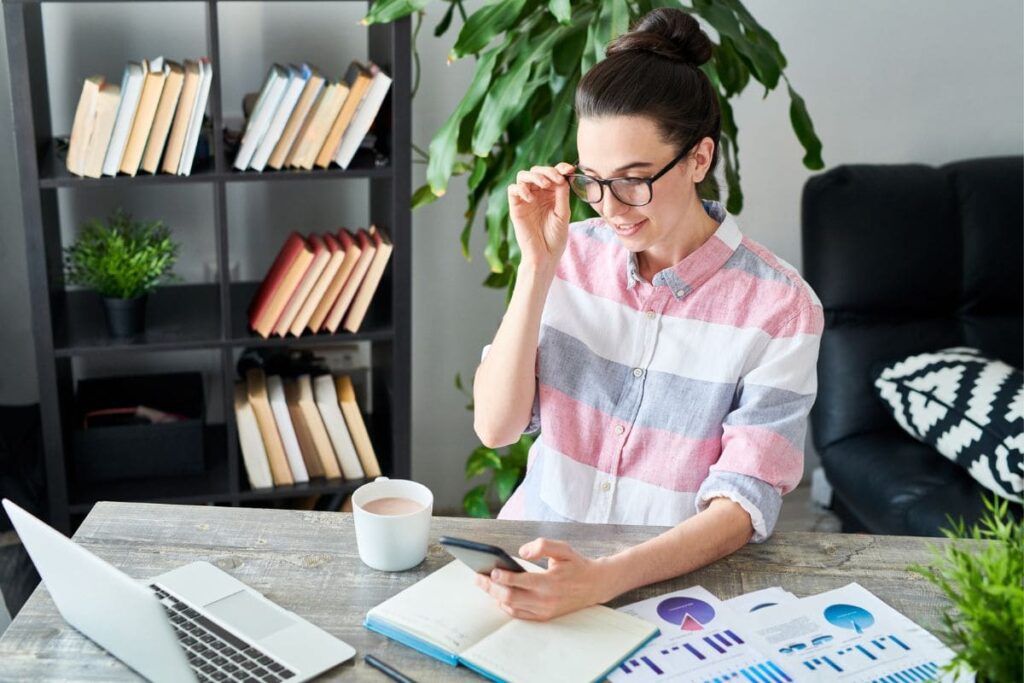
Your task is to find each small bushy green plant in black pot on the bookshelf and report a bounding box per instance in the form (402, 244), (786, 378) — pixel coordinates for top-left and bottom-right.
(65, 209), (178, 337)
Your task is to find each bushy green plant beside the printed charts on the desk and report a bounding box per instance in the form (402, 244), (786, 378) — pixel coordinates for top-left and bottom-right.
(910, 498), (1024, 683)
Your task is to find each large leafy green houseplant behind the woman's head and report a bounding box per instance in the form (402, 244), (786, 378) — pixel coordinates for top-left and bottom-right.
(365, 0), (823, 515)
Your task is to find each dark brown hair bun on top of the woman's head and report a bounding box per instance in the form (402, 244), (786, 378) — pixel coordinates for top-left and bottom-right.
(606, 7), (712, 67)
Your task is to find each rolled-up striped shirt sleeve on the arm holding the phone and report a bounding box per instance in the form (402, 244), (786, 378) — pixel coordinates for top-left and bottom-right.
(696, 304), (824, 543)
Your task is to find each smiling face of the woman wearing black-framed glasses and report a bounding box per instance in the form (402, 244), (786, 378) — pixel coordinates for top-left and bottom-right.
(577, 117), (714, 252)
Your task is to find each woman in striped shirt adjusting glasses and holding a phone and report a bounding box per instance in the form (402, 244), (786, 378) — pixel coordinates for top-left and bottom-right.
(474, 9), (822, 620)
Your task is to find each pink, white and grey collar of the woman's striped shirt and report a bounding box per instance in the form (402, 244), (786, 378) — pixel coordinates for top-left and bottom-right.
(626, 200), (742, 299)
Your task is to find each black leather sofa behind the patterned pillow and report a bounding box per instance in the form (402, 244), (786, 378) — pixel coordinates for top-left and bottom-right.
(802, 157), (1024, 536)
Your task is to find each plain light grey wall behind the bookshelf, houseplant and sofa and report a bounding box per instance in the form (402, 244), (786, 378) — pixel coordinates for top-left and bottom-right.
(0, 0), (1024, 510)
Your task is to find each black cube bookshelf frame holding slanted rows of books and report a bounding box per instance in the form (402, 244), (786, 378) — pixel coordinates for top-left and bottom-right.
(3, 0), (412, 531)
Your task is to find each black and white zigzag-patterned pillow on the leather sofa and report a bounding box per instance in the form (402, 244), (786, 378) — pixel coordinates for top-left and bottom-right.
(874, 347), (1024, 503)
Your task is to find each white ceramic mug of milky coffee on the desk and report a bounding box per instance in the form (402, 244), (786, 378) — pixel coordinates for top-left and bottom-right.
(352, 477), (434, 571)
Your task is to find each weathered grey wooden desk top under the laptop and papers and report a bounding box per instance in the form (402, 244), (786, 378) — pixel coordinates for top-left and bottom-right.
(0, 503), (945, 682)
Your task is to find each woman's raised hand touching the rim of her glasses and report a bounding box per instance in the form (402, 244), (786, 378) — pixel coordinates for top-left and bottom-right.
(508, 162), (575, 270)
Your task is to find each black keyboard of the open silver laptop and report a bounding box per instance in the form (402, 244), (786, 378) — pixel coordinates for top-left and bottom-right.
(150, 585), (295, 683)
